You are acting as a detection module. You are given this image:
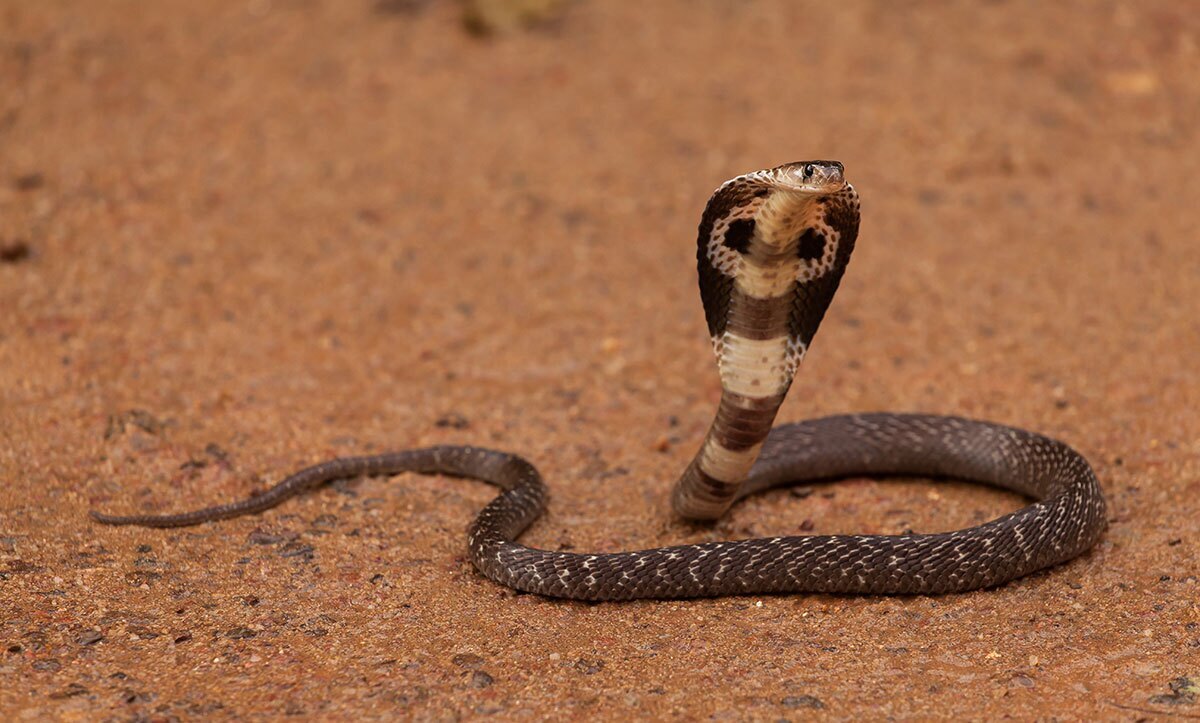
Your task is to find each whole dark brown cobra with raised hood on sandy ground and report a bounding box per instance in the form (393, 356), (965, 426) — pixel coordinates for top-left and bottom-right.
(91, 161), (1106, 600)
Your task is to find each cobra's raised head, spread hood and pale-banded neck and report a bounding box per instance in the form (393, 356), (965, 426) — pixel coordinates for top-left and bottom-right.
(672, 161), (858, 519)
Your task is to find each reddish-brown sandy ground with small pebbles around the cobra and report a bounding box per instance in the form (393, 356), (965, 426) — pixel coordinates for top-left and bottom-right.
(0, 0), (1200, 721)
